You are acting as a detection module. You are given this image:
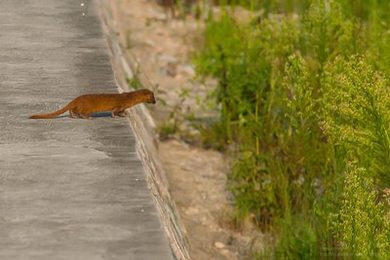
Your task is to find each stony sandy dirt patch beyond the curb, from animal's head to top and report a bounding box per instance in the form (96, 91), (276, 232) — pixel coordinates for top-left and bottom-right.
(107, 0), (208, 121)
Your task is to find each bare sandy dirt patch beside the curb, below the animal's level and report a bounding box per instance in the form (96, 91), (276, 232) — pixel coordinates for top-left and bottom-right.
(160, 140), (261, 259)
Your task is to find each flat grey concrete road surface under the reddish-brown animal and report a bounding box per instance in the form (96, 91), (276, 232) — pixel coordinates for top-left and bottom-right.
(0, 0), (172, 260)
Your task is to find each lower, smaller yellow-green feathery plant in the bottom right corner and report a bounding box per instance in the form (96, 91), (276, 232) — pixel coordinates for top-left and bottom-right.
(336, 161), (390, 259)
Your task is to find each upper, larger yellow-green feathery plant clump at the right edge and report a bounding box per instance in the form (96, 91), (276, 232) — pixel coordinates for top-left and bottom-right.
(323, 56), (390, 183)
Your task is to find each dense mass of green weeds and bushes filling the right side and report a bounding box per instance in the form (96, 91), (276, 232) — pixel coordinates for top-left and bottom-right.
(195, 0), (390, 259)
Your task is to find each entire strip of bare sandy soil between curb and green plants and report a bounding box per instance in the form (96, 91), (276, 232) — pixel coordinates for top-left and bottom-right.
(106, 0), (262, 260)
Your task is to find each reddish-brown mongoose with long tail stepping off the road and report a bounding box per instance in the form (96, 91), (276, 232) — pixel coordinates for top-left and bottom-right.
(30, 89), (156, 119)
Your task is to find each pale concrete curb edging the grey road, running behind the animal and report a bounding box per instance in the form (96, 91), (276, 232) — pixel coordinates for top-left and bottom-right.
(98, 0), (190, 259)
